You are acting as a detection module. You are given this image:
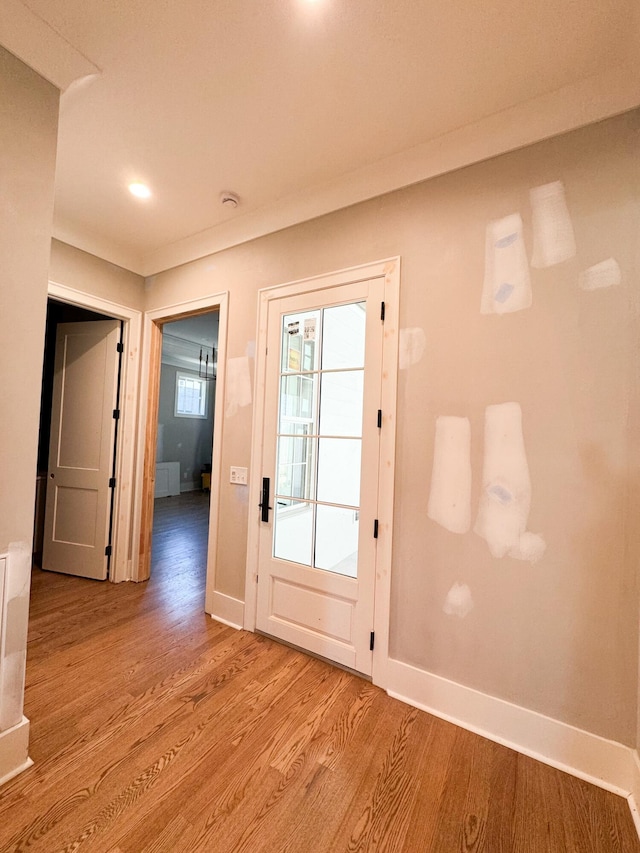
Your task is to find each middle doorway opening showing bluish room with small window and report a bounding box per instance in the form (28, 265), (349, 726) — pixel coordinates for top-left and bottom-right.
(151, 310), (219, 589)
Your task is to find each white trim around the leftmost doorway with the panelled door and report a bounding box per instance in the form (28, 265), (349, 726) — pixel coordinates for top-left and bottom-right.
(47, 281), (142, 583)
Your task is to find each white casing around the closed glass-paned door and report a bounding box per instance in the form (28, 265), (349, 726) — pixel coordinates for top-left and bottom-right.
(244, 257), (400, 687)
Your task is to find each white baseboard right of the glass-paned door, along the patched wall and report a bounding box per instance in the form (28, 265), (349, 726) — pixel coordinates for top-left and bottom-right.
(386, 659), (640, 836)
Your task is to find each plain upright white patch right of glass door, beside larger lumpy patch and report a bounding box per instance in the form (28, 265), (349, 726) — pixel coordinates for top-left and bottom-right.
(427, 415), (471, 533)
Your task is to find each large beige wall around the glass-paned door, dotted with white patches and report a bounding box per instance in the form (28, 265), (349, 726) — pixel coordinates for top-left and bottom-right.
(147, 112), (640, 745)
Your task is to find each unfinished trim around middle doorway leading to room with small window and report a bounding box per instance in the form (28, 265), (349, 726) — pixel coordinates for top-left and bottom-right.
(132, 291), (229, 615)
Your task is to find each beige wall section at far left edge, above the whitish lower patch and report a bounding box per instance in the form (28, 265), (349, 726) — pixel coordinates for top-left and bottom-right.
(0, 49), (58, 553)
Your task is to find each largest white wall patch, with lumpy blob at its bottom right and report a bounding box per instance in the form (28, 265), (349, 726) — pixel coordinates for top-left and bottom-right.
(474, 403), (546, 563)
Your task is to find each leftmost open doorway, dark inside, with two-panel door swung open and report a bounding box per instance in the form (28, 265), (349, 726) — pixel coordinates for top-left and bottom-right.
(34, 299), (123, 580)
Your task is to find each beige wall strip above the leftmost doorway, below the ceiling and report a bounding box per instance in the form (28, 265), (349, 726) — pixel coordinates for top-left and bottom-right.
(49, 240), (144, 311)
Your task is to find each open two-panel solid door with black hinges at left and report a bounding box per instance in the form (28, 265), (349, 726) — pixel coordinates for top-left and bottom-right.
(42, 320), (120, 580)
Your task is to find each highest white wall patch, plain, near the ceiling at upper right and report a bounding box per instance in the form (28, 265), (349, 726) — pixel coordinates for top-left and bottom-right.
(529, 181), (576, 269)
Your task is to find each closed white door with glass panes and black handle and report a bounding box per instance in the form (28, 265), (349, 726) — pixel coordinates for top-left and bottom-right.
(256, 278), (384, 674)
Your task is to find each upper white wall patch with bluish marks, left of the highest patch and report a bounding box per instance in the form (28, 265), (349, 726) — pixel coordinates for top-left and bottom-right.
(480, 213), (532, 314)
